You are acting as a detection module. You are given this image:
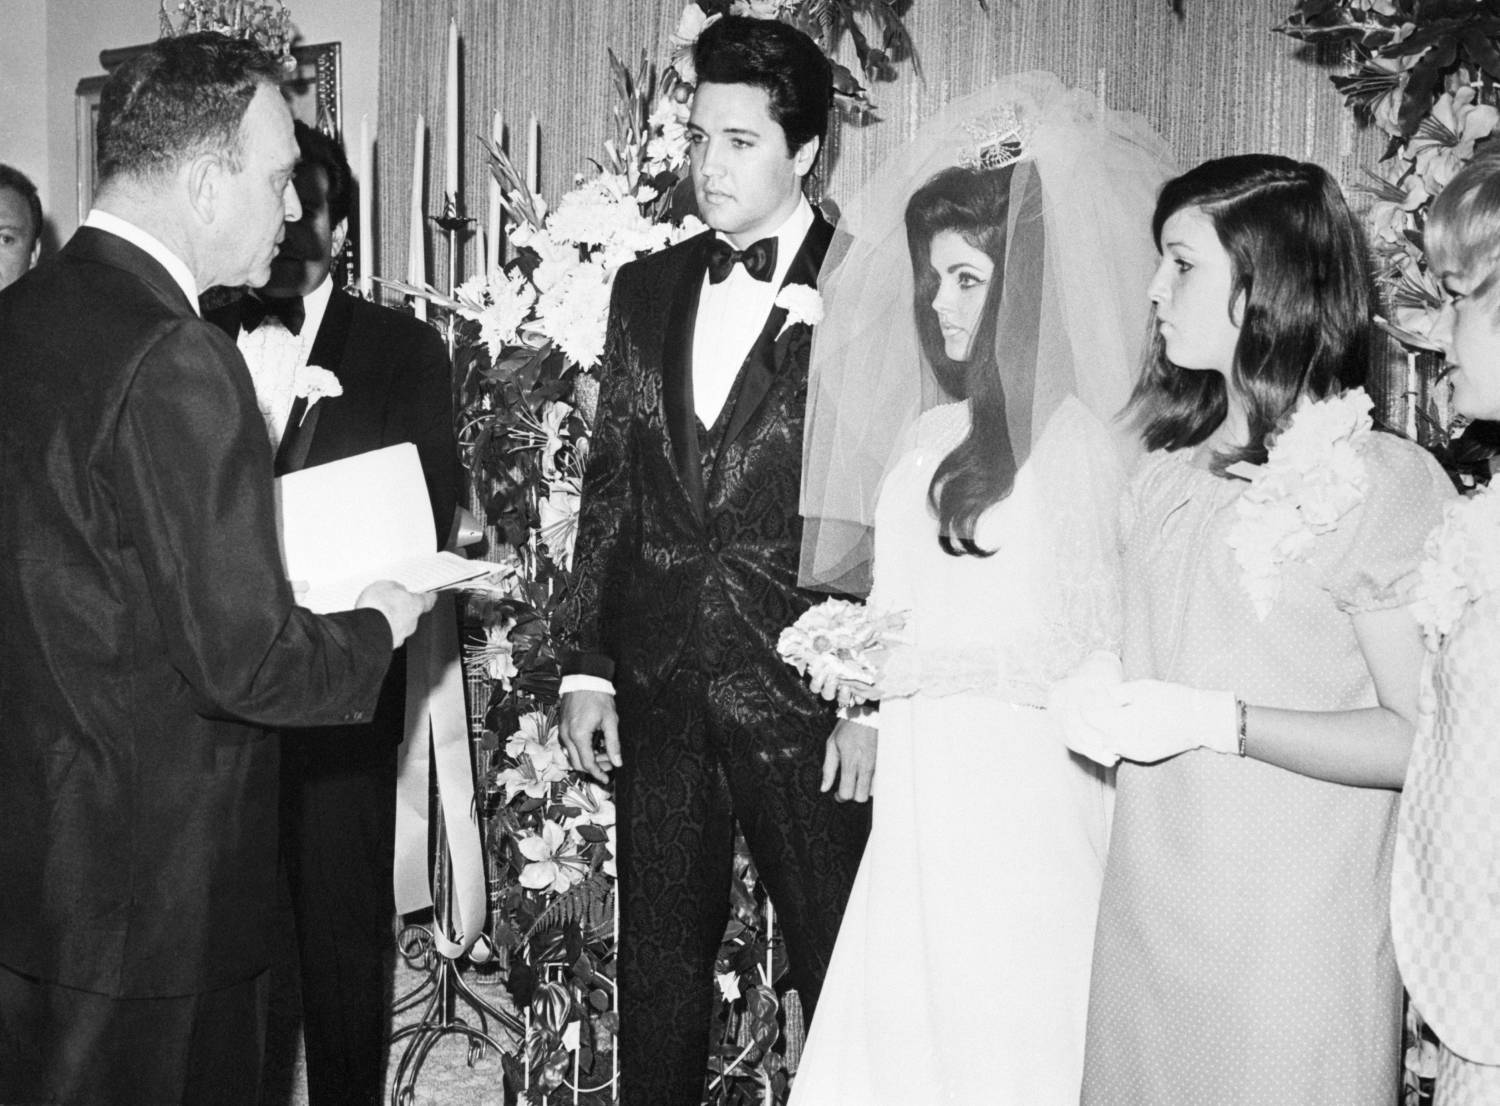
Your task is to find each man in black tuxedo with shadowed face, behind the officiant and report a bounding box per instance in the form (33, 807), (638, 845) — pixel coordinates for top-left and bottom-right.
(209, 122), (459, 1106)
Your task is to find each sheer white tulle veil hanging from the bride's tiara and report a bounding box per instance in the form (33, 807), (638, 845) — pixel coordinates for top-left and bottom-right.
(801, 74), (1176, 594)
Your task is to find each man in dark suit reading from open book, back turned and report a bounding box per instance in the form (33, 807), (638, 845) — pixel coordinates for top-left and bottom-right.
(0, 33), (432, 1106)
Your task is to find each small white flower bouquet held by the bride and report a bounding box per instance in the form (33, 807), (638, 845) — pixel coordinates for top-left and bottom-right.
(776, 599), (906, 707)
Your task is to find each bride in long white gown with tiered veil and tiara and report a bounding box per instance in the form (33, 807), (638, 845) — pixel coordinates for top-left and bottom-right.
(792, 74), (1172, 1106)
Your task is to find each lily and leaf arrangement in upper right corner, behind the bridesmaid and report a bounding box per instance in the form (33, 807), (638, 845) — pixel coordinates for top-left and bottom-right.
(1278, 0), (1500, 470)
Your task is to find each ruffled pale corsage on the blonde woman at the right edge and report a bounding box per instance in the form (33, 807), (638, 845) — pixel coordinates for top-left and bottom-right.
(1412, 486), (1500, 650)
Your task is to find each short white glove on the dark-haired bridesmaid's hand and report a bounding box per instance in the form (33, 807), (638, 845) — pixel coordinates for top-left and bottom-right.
(1080, 680), (1239, 764)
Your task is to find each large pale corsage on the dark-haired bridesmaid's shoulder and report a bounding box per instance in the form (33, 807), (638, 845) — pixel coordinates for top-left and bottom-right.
(1229, 389), (1373, 620)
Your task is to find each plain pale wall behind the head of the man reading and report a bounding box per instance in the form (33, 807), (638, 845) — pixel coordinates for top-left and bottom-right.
(0, 0), (380, 245)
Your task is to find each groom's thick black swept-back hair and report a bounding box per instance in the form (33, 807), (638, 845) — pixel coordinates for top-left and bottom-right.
(693, 15), (834, 162)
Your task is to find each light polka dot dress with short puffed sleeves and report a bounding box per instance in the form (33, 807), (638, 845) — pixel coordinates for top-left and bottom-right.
(1083, 434), (1452, 1106)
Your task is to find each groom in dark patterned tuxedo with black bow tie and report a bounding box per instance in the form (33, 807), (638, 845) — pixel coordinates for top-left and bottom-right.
(558, 17), (870, 1106)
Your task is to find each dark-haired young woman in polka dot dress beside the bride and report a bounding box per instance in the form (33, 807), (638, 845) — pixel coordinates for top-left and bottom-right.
(1065, 155), (1452, 1106)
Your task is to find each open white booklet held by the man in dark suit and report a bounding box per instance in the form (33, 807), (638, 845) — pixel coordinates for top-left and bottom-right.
(276, 443), (501, 614)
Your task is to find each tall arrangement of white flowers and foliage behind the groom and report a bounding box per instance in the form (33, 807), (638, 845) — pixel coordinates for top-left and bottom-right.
(386, 0), (960, 1103)
